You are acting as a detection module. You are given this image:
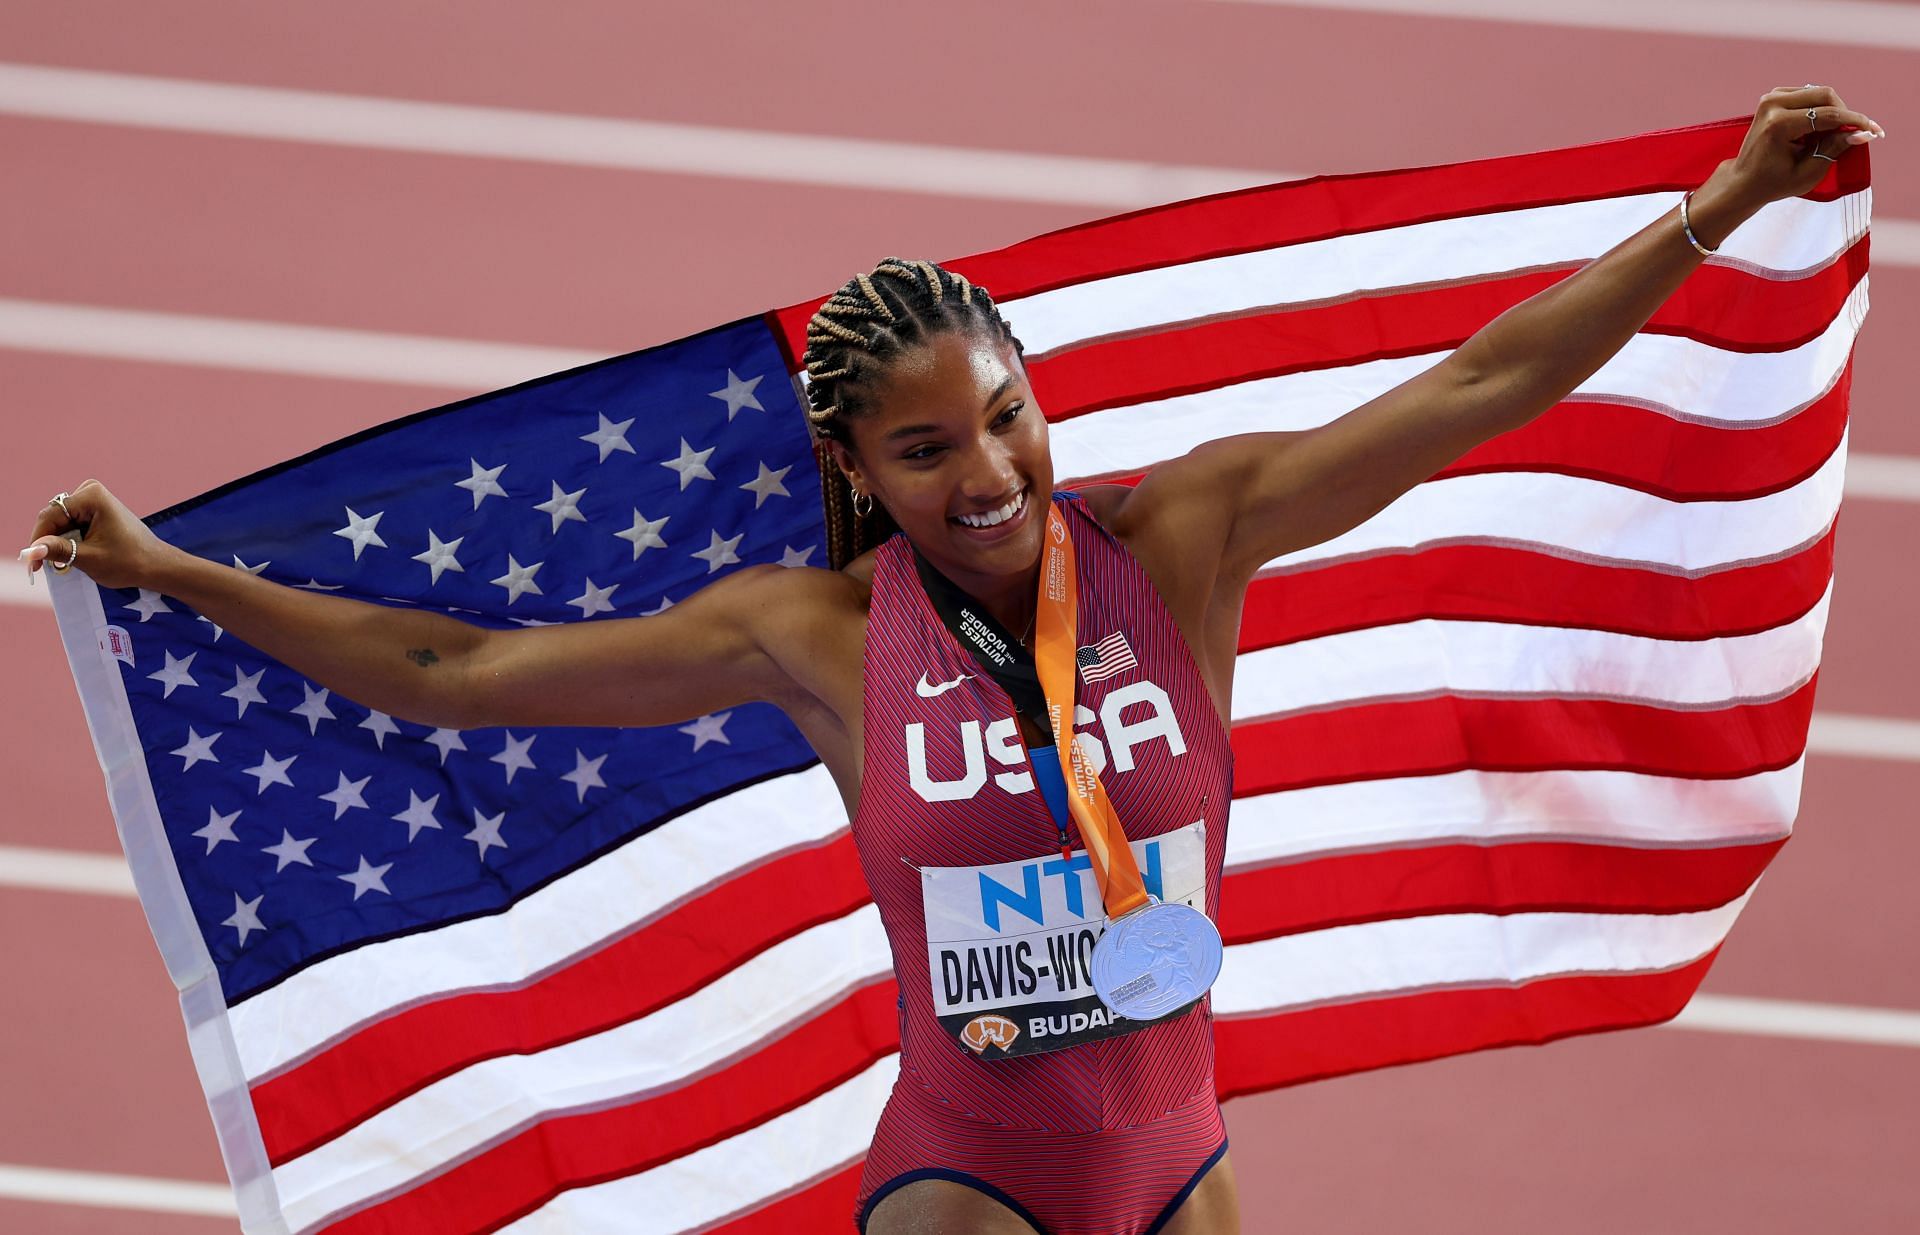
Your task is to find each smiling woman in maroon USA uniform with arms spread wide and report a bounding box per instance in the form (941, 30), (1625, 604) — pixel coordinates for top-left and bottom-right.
(21, 86), (1882, 1235)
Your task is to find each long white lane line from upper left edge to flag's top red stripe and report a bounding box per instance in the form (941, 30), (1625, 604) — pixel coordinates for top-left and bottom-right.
(0, 63), (1290, 209)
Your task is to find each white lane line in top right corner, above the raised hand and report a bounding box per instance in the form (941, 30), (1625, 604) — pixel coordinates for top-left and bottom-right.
(1235, 0), (1920, 49)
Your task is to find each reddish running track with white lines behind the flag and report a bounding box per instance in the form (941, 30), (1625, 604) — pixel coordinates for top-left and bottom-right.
(0, 0), (1920, 1235)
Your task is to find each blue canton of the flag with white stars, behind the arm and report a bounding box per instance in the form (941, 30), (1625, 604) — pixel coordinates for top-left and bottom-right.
(104, 319), (826, 1001)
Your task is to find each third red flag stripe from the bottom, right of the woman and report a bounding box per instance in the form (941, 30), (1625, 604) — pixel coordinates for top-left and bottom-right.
(1233, 678), (1816, 797)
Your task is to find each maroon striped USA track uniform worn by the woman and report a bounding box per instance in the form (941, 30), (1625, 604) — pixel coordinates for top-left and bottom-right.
(852, 494), (1233, 1235)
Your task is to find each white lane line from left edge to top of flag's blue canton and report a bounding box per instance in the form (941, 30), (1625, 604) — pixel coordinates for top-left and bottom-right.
(0, 298), (603, 392)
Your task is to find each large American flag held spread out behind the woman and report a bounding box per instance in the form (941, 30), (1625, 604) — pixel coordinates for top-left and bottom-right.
(56, 121), (1870, 1235)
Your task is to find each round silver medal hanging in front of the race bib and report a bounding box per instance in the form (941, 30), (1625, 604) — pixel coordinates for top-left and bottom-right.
(1092, 901), (1221, 1020)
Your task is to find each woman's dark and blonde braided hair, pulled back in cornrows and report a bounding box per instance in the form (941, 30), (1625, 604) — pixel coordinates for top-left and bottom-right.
(804, 257), (1023, 570)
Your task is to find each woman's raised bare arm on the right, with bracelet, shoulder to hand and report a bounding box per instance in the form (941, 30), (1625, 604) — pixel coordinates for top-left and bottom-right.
(1125, 86), (1884, 580)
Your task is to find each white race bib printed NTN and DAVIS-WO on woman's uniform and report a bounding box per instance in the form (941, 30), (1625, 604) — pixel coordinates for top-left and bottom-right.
(920, 820), (1206, 1058)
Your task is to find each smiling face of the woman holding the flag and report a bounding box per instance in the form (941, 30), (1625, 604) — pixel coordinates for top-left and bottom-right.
(835, 332), (1054, 599)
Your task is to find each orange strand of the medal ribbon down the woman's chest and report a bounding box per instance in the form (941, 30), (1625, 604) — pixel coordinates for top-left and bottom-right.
(1033, 503), (1148, 920)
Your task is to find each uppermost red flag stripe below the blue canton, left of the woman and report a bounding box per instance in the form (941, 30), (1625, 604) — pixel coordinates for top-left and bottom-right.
(252, 834), (868, 1166)
